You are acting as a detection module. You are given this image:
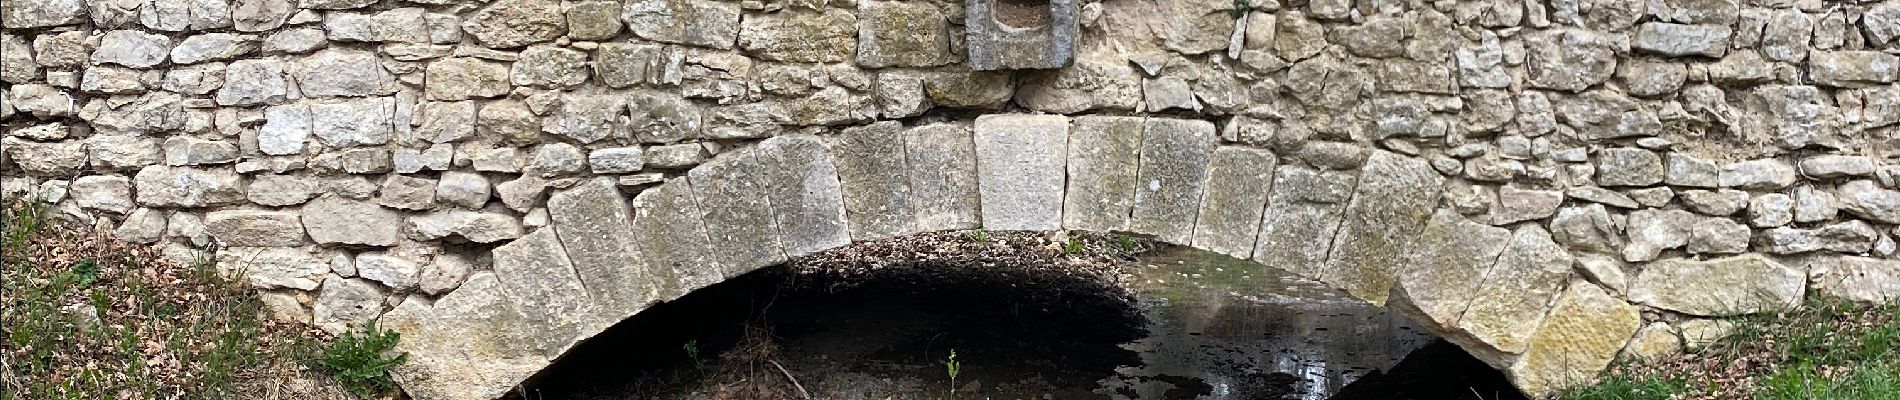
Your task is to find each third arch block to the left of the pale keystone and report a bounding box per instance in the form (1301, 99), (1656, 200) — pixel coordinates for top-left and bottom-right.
(754, 135), (851, 258)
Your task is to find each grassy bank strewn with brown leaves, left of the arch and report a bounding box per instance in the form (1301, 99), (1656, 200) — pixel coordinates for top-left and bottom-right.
(0, 201), (355, 400)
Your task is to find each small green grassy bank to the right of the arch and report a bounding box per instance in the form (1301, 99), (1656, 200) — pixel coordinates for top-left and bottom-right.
(1560, 301), (1900, 400)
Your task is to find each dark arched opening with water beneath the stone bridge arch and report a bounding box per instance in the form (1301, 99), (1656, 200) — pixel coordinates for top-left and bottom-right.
(517, 231), (1522, 400)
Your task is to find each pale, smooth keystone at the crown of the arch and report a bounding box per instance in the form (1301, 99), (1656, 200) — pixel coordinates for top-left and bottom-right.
(977, 114), (1070, 231)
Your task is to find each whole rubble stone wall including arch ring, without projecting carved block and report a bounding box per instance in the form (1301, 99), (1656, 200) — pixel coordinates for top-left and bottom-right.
(0, 0), (1900, 400)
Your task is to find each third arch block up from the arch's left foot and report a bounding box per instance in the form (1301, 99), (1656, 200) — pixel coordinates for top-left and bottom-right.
(547, 178), (680, 320)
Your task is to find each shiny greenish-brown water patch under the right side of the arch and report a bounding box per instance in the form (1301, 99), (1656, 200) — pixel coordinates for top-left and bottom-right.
(1098, 248), (1435, 400)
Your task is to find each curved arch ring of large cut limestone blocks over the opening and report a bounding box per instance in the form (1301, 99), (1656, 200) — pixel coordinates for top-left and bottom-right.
(380, 114), (1642, 398)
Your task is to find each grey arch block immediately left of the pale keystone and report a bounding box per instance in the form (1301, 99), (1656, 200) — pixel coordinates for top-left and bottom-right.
(904, 123), (982, 231)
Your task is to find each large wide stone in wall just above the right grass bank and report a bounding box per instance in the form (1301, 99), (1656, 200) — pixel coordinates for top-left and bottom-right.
(1630, 254), (1807, 317)
